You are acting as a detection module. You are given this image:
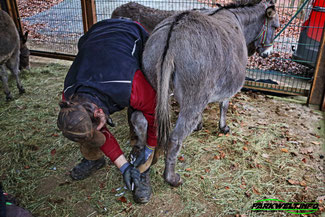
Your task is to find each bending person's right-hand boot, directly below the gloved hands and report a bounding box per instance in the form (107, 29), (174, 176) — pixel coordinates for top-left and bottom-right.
(133, 169), (152, 203)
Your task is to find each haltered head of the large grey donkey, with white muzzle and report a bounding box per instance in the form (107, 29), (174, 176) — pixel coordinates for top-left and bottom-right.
(253, 0), (280, 57)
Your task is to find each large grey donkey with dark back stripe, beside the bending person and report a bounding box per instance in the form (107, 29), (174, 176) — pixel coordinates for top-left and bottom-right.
(143, 1), (279, 186)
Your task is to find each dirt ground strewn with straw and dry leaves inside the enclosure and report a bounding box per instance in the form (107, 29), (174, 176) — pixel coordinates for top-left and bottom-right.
(0, 59), (325, 217)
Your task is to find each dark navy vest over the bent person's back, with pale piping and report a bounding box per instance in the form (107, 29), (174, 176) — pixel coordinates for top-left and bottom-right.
(64, 19), (148, 115)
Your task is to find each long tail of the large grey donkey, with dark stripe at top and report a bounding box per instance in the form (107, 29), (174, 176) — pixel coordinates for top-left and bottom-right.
(154, 11), (189, 158)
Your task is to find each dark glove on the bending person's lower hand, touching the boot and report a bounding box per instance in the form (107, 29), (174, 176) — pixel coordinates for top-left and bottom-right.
(120, 163), (140, 191)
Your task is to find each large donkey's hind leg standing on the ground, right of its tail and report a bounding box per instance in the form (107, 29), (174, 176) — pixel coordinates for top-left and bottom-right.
(164, 104), (205, 187)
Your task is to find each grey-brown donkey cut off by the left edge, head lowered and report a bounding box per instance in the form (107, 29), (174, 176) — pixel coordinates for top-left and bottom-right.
(0, 10), (29, 100)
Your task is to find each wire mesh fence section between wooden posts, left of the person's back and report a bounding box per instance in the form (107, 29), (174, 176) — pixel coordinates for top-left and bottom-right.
(18, 0), (83, 54)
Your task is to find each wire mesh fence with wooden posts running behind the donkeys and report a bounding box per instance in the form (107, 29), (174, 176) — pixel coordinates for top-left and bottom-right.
(0, 0), (325, 101)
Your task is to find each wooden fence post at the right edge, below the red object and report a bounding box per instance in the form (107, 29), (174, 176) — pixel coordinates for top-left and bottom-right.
(307, 29), (325, 110)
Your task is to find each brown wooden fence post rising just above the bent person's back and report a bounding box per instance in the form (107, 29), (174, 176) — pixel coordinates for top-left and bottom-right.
(81, 0), (97, 33)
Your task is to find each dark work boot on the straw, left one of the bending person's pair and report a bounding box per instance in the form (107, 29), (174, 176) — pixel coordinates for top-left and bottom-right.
(70, 157), (105, 180)
